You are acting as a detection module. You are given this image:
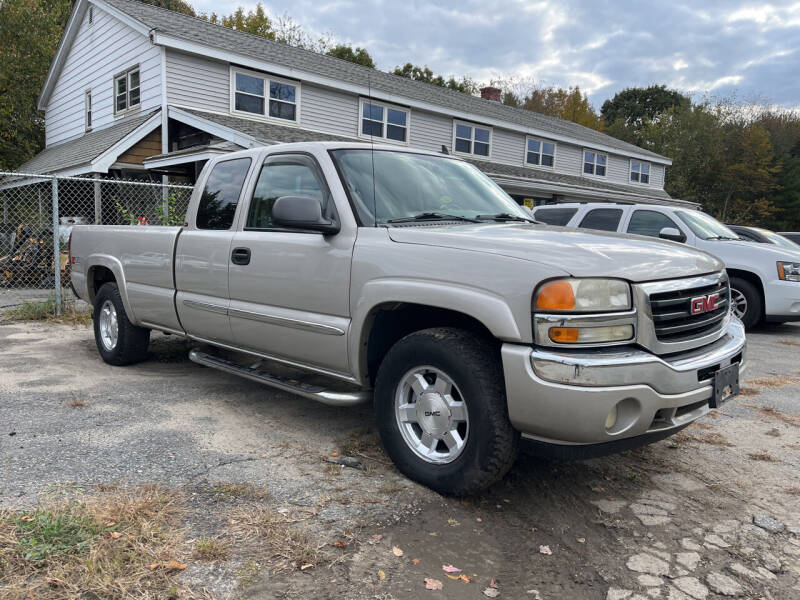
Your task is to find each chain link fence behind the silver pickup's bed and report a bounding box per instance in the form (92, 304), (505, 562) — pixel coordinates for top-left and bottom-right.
(0, 172), (193, 311)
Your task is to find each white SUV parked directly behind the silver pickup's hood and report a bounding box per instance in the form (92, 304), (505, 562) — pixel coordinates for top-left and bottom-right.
(534, 203), (800, 328)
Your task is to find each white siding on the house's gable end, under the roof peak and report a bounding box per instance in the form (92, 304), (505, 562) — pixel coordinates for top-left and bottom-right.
(45, 6), (161, 146)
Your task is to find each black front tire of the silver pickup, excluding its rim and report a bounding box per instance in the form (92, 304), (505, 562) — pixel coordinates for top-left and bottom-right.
(375, 327), (519, 496)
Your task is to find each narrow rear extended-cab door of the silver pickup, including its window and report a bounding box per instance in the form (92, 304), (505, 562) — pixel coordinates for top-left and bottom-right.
(175, 158), (252, 344)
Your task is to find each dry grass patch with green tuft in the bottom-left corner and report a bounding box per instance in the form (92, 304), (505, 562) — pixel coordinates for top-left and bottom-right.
(0, 486), (191, 600)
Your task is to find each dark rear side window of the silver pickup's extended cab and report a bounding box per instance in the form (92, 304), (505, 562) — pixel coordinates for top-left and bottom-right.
(195, 158), (252, 230)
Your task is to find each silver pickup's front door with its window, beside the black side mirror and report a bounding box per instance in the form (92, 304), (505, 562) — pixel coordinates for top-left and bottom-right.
(229, 153), (355, 374)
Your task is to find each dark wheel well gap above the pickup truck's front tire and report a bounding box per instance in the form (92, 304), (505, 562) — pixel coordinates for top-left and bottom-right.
(362, 302), (500, 384)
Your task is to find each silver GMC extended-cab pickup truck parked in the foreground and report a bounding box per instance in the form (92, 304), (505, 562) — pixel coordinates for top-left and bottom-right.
(70, 143), (745, 494)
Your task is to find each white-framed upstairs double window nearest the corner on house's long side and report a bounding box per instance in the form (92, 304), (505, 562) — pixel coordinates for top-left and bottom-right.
(233, 71), (300, 121)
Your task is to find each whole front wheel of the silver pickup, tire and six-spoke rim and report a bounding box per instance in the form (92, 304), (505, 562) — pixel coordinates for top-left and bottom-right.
(375, 328), (519, 495)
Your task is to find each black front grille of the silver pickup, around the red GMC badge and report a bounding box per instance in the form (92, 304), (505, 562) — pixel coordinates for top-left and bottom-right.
(650, 280), (730, 342)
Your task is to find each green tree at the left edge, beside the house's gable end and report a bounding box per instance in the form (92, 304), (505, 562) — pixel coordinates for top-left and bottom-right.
(0, 0), (71, 170)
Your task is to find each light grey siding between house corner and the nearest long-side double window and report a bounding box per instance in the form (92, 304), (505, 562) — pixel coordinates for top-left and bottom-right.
(166, 50), (231, 113)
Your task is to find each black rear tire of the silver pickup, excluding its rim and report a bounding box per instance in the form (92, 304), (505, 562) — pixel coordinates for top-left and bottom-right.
(92, 283), (150, 367)
